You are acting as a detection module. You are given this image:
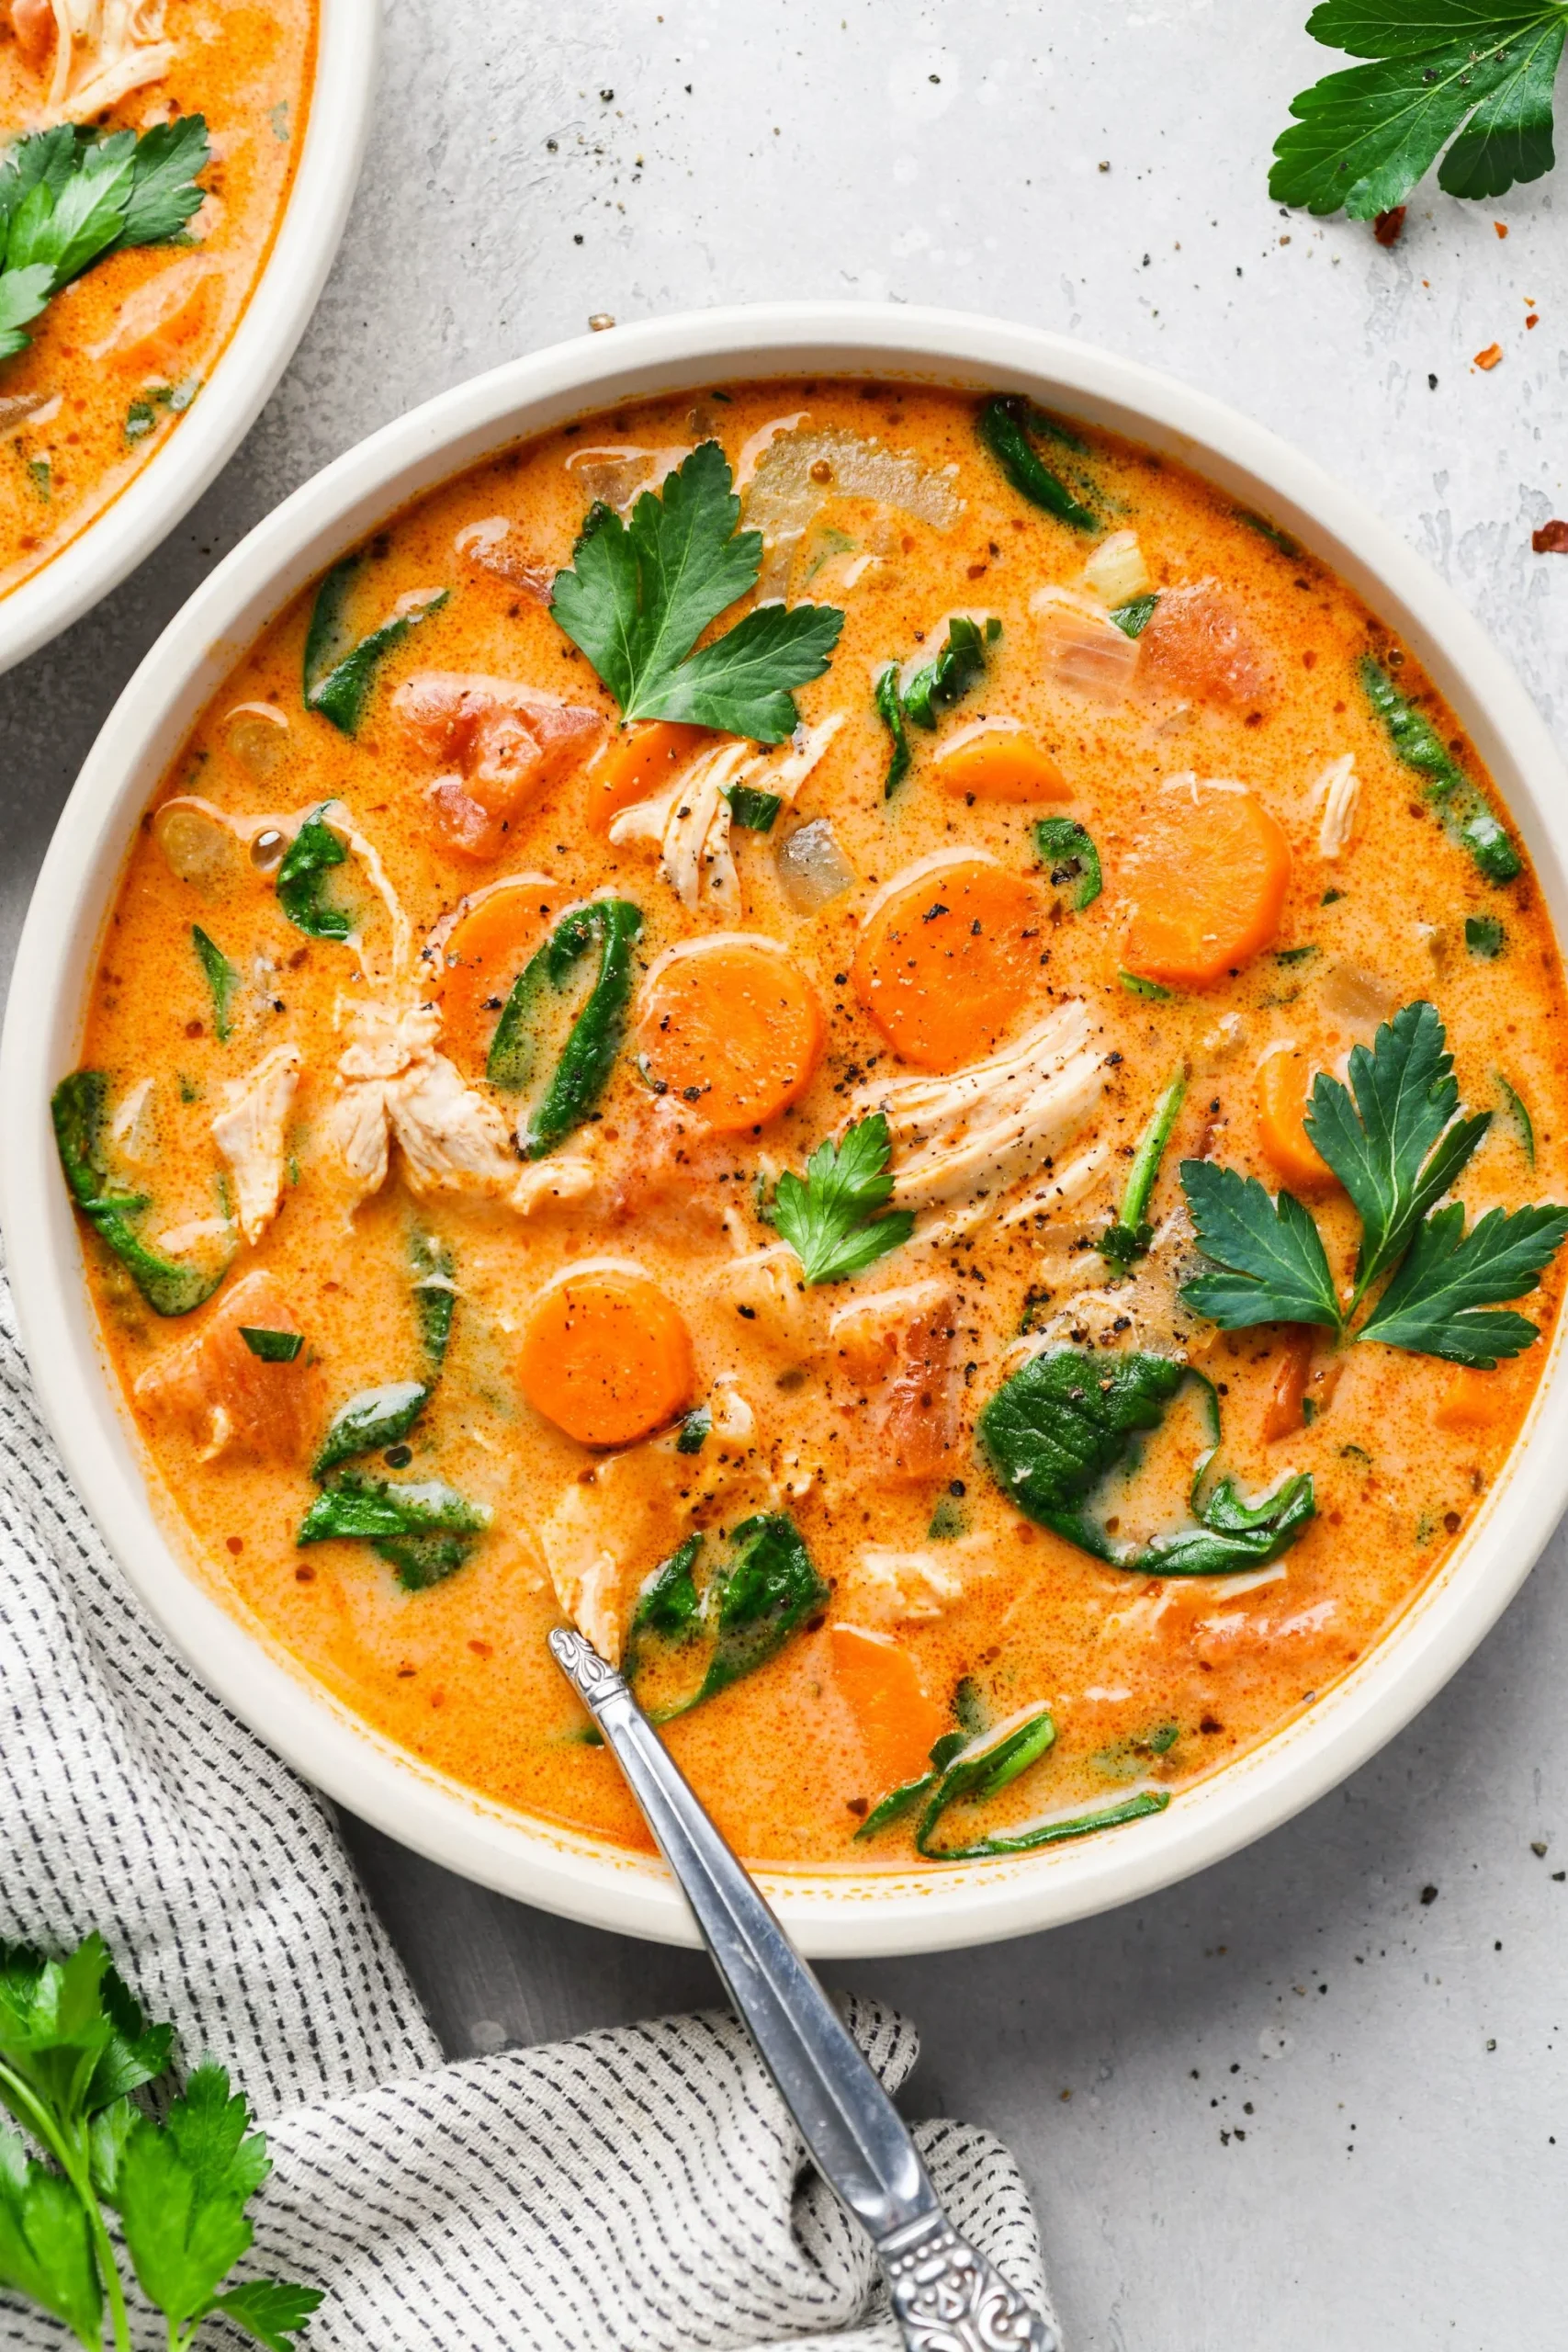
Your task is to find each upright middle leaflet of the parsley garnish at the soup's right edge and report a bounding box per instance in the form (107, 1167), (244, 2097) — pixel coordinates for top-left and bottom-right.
(1295, 1002), (1514, 1322)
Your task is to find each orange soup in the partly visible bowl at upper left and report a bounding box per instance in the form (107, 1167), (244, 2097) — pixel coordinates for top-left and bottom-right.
(0, 0), (315, 595)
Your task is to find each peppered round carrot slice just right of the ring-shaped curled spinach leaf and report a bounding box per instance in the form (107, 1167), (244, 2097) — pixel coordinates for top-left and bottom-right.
(637, 932), (823, 1136)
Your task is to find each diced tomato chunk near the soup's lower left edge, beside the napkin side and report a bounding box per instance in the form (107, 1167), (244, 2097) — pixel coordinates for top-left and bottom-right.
(136, 1268), (324, 1463)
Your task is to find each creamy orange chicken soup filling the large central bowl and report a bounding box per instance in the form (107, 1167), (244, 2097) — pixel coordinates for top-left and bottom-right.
(62, 381), (1568, 1870)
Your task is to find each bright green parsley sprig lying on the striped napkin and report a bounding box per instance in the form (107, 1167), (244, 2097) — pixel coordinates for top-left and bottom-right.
(0, 1933), (322, 2352)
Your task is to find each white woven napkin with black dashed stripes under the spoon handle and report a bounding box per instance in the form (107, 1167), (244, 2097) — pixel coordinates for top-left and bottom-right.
(0, 1263), (1062, 2352)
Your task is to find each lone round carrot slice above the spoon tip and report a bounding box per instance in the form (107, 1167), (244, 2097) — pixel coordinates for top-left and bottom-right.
(517, 1265), (696, 1446)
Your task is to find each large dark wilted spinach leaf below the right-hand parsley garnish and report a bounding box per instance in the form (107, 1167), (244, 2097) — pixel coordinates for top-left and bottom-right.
(976, 1348), (1314, 1576)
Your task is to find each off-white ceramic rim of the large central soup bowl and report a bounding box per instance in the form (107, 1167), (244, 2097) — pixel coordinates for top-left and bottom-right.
(0, 303), (1568, 1957)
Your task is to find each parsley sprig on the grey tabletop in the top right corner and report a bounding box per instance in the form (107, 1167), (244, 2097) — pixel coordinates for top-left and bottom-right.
(1269, 0), (1568, 221)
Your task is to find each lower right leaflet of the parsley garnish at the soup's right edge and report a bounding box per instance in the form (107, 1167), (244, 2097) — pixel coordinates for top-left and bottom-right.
(1357, 1200), (1568, 1371)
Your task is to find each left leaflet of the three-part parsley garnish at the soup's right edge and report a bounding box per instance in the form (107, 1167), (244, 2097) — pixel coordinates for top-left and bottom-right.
(1180, 1159), (1342, 1331)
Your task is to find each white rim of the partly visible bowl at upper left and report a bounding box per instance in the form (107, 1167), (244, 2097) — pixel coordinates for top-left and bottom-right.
(0, 0), (381, 673)
